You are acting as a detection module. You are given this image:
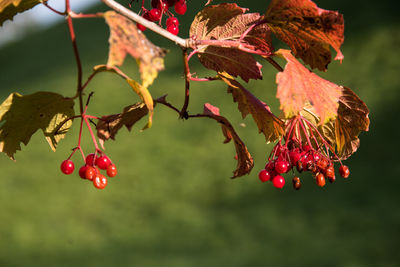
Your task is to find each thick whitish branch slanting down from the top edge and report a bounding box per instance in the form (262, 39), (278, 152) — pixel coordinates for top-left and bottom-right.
(102, 0), (192, 48)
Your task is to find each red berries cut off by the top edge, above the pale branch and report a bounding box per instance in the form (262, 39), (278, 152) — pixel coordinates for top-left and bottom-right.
(133, 0), (187, 35)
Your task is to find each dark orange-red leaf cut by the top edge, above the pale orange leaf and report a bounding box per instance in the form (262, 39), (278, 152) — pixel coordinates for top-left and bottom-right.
(266, 0), (344, 71)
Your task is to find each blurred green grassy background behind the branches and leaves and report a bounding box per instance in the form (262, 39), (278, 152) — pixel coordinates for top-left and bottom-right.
(0, 0), (400, 267)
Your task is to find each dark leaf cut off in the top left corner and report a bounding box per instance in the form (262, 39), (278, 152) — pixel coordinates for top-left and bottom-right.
(0, 0), (47, 26)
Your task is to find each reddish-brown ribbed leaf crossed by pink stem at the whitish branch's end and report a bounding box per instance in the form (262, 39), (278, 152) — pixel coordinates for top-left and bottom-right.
(190, 3), (273, 82)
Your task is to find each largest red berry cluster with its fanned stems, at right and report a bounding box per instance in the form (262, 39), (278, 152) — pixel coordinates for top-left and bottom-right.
(258, 117), (350, 190)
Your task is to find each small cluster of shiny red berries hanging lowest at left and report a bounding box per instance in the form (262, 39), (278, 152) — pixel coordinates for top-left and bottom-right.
(60, 153), (117, 189)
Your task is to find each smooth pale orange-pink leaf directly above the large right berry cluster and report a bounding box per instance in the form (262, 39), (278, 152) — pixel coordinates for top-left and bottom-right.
(276, 49), (342, 122)
